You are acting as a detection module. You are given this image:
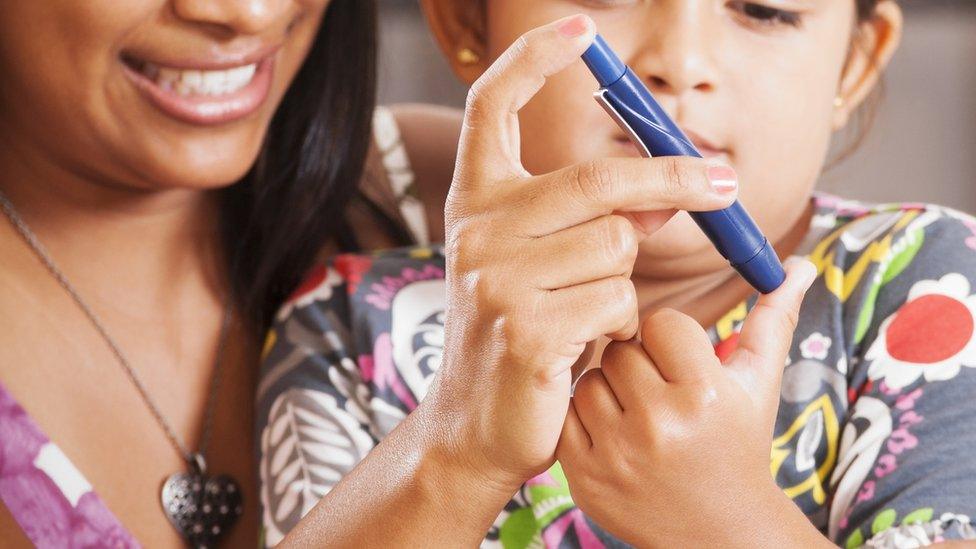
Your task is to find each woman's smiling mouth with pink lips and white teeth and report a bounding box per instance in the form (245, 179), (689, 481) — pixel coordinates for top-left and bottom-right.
(122, 48), (277, 125)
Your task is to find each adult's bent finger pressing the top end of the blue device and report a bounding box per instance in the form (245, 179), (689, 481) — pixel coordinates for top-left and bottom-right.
(460, 15), (596, 180)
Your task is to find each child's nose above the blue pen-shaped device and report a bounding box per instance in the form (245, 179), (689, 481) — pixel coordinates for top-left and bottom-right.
(631, 2), (717, 96)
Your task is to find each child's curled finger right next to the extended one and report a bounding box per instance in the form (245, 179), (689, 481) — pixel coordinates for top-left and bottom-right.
(641, 309), (719, 383)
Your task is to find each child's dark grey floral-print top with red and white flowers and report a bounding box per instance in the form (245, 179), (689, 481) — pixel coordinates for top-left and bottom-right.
(257, 115), (976, 547)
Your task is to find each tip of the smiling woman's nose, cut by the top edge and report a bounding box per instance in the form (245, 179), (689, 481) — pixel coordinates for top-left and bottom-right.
(173, 0), (292, 34)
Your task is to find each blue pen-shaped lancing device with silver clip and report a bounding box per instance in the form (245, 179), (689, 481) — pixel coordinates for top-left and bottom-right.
(583, 35), (786, 294)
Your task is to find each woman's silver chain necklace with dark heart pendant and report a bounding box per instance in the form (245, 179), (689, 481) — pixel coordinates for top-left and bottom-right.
(0, 191), (243, 548)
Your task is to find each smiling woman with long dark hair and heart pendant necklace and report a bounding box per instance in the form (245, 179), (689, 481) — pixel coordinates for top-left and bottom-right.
(0, 0), (375, 547)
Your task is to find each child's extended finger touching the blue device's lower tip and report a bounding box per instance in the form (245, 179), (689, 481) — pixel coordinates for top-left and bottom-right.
(729, 258), (817, 380)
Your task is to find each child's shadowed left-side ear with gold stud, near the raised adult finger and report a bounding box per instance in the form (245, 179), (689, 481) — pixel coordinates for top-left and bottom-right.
(420, 0), (490, 85)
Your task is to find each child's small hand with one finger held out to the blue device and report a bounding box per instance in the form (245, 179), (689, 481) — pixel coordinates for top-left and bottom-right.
(556, 261), (825, 546)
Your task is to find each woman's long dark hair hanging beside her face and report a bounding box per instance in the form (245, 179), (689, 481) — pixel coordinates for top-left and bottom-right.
(220, 0), (376, 333)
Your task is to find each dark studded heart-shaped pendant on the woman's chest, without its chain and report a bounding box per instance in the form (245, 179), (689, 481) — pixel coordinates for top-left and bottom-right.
(161, 460), (244, 549)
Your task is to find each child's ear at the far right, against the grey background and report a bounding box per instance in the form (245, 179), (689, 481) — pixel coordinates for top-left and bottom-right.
(833, 0), (903, 131)
